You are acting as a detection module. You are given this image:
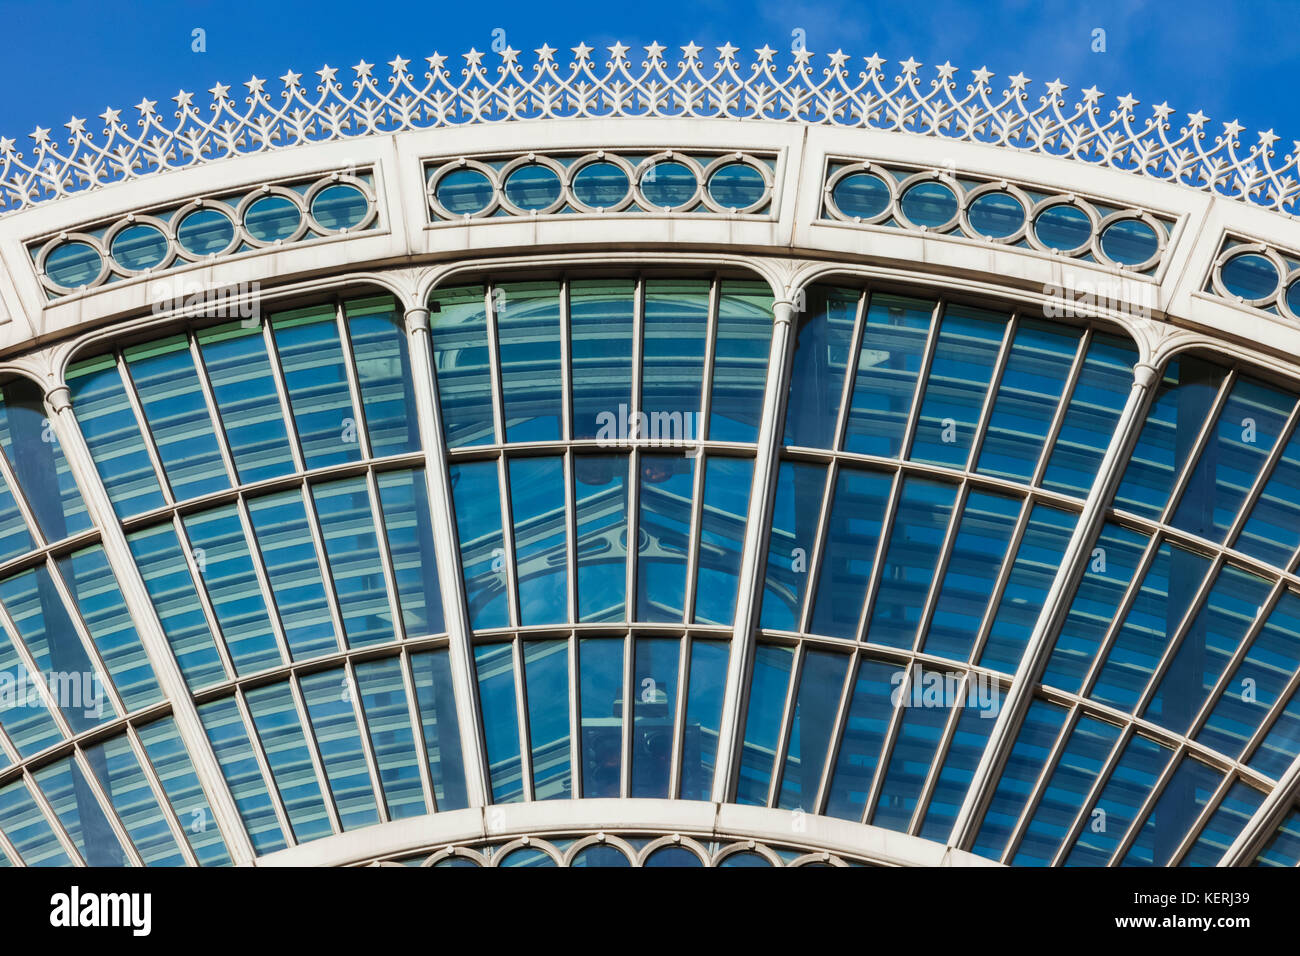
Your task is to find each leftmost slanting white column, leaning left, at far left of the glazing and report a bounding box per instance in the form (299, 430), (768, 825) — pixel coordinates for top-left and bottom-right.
(46, 385), (256, 865)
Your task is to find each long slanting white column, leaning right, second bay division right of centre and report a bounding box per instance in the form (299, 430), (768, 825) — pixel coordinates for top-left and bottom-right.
(949, 363), (1160, 849)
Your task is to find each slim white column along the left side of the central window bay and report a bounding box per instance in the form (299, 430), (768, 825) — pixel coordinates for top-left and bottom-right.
(406, 307), (491, 806)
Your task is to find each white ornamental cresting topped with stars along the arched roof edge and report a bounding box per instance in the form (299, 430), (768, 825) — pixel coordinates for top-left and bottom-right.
(0, 43), (1300, 216)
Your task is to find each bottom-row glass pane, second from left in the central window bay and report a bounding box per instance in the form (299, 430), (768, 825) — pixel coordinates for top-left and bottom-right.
(524, 641), (575, 800)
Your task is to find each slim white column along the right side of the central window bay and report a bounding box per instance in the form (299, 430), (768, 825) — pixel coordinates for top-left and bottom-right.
(712, 299), (794, 804)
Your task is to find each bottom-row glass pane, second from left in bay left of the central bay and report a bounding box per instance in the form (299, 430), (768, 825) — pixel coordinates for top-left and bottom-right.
(247, 683), (334, 843)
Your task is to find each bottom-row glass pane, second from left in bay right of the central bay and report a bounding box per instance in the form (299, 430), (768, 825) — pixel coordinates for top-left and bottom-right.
(776, 650), (849, 813)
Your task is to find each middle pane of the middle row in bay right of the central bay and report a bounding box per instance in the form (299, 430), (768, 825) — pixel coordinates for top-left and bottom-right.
(865, 477), (957, 649)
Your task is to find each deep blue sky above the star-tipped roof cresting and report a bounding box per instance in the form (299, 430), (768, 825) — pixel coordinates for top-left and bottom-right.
(0, 0), (1300, 152)
